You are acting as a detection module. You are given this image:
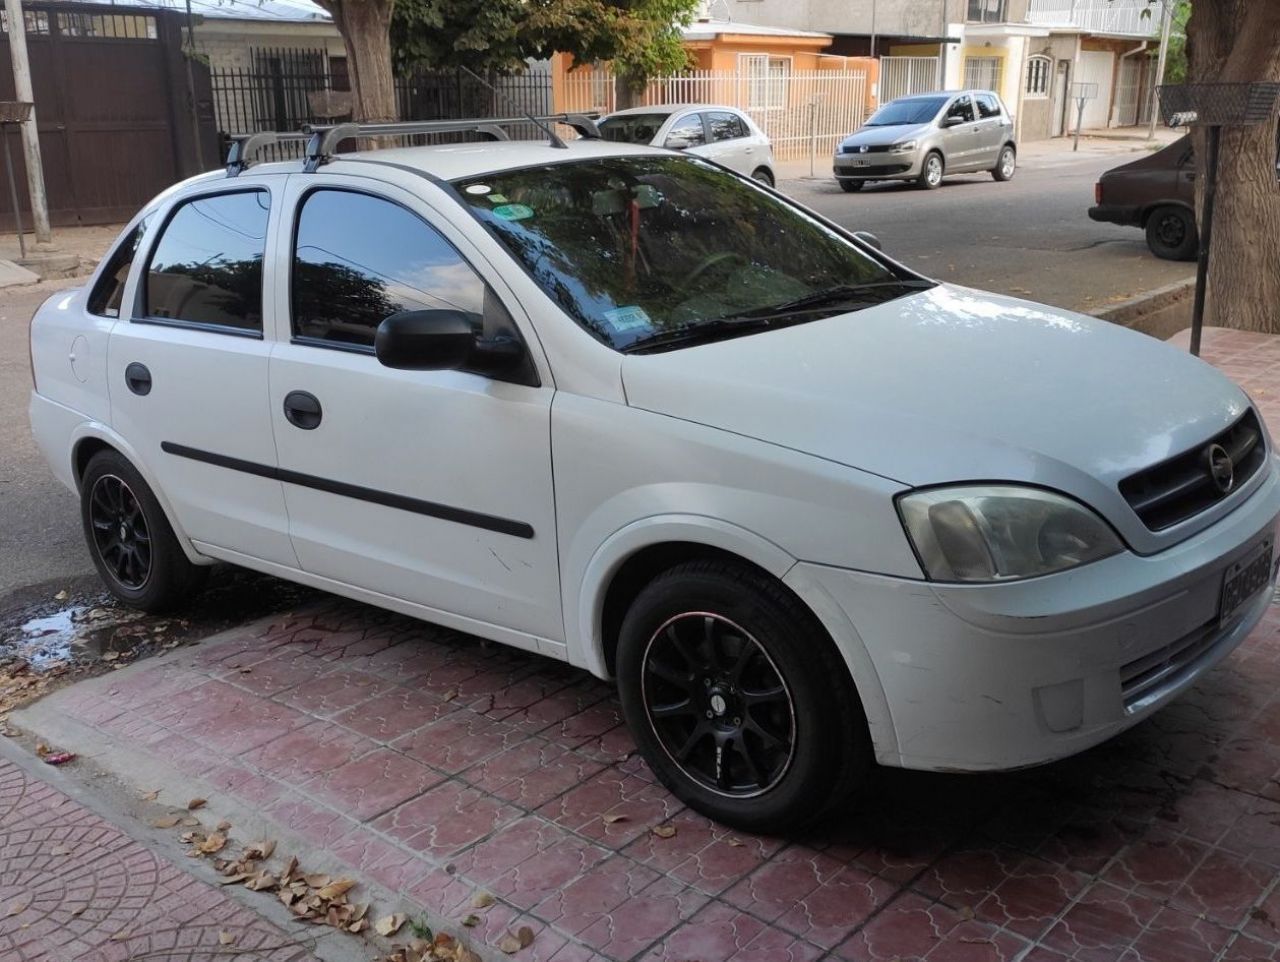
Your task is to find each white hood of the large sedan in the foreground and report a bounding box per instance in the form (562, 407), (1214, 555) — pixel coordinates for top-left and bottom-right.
(622, 284), (1248, 542)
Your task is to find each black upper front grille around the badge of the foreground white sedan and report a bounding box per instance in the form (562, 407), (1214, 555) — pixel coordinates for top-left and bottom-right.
(1120, 408), (1266, 531)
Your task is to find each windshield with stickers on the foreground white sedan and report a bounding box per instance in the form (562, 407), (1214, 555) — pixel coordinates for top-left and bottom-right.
(453, 156), (931, 351)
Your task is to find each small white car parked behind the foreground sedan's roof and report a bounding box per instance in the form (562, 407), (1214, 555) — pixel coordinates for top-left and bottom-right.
(599, 104), (778, 187)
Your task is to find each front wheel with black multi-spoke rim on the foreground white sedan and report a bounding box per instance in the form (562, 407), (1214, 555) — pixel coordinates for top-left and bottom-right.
(617, 562), (872, 832)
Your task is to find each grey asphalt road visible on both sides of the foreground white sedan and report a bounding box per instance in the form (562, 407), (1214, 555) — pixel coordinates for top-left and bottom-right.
(0, 150), (1192, 617)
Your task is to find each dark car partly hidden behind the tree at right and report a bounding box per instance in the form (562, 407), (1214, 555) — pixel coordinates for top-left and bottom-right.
(1089, 137), (1199, 261)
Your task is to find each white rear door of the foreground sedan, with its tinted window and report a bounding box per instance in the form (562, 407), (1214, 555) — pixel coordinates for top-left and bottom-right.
(108, 175), (297, 567)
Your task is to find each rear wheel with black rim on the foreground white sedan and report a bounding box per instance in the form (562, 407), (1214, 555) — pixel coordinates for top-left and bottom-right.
(81, 450), (209, 613)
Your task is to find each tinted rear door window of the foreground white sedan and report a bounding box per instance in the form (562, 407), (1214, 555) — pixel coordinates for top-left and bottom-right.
(146, 191), (270, 331)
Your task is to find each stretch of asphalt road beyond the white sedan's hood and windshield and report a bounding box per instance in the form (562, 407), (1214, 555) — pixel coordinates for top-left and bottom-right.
(783, 154), (1196, 311)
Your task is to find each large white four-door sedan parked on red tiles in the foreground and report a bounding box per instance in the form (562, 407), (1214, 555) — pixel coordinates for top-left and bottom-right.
(31, 118), (1280, 829)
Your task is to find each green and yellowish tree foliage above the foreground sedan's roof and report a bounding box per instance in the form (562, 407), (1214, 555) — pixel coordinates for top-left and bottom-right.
(392, 0), (696, 77)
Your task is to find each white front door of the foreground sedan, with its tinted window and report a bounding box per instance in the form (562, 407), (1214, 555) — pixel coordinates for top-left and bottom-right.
(270, 180), (563, 646)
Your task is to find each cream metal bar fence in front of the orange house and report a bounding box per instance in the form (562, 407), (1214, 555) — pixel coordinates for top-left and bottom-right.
(557, 69), (868, 160)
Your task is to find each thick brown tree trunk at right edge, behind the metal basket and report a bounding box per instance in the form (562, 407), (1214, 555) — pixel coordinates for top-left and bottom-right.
(1187, 0), (1280, 334)
